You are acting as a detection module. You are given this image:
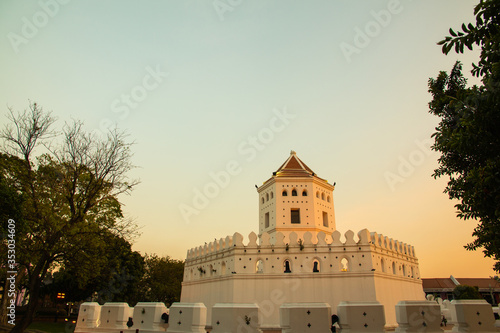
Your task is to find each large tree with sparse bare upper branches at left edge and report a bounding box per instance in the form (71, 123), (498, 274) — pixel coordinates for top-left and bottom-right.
(0, 103), (136, 332)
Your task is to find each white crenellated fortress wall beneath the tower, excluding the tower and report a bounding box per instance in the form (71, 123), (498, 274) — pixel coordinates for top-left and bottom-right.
(181, 229), (424, 327)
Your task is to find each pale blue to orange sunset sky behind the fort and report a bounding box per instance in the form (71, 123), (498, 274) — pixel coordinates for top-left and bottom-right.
(0, 0), (494, 277)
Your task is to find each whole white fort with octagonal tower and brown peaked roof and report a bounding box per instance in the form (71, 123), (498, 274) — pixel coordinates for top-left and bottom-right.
(181, 151), (424, 329)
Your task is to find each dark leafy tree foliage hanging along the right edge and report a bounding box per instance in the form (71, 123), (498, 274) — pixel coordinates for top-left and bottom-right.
(429, 0), (500, 272)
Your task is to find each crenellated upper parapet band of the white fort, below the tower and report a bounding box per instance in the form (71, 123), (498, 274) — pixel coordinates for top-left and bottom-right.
(184, 229), (419, 282)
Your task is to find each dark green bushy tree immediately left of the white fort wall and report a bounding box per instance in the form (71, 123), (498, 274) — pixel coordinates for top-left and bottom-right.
(141, 255), (184, 306)
